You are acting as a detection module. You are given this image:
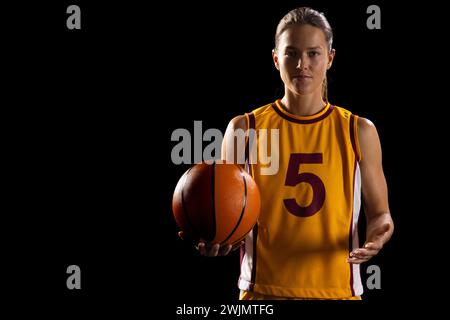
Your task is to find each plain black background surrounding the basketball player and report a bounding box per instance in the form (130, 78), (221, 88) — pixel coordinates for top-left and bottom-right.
(2, 0), (445, 319)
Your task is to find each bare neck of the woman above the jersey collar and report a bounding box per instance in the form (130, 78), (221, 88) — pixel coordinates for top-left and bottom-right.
(281, 90), (326, 116)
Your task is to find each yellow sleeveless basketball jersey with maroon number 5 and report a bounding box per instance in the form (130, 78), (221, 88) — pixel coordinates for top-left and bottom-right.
(238, 100), (363, 299)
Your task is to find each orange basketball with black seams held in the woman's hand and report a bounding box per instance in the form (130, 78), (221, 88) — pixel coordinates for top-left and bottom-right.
(172, 162), (261, 245)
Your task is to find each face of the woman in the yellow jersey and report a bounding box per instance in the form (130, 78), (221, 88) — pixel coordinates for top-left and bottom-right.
(272, 24), (335, 95)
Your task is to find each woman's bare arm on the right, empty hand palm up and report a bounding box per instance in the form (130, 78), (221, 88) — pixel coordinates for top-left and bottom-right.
(348, 118), (394, 263)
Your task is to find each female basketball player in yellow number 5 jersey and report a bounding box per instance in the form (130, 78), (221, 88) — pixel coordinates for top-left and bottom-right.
(179, 8), (394, 299)
